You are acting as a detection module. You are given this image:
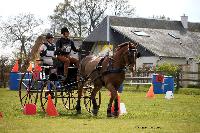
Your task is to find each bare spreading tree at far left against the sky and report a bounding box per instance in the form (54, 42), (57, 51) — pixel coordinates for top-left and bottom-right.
(0, 14), (42, 60)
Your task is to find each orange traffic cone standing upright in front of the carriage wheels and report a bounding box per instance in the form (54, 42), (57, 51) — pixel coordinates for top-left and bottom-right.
(46, 94), (59, 116)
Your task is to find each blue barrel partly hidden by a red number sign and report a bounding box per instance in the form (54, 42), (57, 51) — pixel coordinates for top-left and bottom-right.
(152, 74), (164, 94)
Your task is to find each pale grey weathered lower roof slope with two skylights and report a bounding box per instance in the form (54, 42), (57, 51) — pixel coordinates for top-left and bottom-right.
(111, 26), (200, 58)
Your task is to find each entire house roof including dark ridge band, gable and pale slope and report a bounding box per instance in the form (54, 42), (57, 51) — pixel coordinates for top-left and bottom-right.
(85, 16), (200, 58)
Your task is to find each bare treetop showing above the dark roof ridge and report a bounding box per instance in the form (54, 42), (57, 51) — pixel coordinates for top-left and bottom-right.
(110, 0), (135, 17)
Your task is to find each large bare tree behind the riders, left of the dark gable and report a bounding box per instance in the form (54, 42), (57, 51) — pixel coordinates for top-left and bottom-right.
(50, 0), (107, 37)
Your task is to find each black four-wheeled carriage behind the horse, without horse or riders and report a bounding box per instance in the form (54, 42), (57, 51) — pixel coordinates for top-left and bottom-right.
(19, 50), (101, 112)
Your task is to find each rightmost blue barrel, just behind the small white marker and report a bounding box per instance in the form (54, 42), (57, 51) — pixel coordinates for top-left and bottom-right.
(164, 76), (174, 93)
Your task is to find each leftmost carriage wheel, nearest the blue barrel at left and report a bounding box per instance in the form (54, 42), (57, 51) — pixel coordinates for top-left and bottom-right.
(19, 72), (41, 107)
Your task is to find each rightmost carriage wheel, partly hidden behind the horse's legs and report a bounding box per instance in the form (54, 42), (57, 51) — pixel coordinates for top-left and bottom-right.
(83, 83), (101, 113)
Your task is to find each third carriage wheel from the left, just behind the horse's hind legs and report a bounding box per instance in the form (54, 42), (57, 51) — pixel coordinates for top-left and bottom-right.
(61, 88), (78, 110)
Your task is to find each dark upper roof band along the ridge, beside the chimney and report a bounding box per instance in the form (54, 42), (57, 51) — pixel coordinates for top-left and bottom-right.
(109, 16), (200, 32)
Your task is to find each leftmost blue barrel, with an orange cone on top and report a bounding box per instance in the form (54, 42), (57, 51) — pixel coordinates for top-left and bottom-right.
(9, 72), (20, 90)
